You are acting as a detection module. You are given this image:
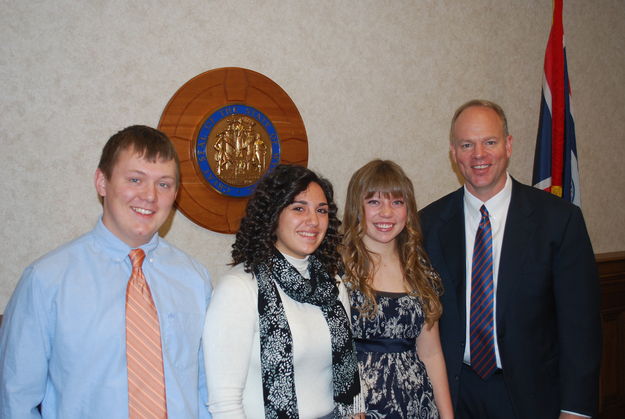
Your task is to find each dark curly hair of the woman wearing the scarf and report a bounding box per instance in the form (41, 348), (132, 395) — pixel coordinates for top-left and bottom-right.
(230, 164), (341, 276)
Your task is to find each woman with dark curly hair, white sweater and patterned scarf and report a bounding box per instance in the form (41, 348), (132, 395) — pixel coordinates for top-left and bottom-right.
(204, 165), (360, 419)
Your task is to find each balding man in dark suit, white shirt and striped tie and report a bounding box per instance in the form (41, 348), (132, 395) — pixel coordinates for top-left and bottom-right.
(420, 100), (601, 419)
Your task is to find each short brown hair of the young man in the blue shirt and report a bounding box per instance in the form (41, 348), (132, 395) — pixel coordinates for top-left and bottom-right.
(98, 125), (180, 186)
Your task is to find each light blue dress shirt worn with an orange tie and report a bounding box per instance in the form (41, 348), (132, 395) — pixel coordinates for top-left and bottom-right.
(0, 220), (211, 419)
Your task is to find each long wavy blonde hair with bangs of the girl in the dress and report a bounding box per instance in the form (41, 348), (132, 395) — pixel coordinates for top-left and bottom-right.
(341, 159), (443, 326)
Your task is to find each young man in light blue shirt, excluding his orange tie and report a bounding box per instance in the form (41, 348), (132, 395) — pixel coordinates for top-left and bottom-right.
(0, 126), (210, 419)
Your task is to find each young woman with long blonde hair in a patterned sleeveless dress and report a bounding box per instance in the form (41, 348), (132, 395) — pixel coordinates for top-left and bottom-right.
(342, 160), (453, 419)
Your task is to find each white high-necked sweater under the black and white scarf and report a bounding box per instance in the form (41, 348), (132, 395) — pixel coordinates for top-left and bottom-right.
(203, 256), (349, 419)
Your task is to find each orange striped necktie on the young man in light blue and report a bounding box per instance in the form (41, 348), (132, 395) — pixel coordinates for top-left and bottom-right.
(126, 249), (167, 419)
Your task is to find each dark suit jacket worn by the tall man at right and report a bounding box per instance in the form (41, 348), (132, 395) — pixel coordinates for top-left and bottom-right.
(420, 180), (601, 419)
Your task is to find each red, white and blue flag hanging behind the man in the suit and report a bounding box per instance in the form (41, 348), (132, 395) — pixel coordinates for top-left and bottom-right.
(532, 0), (581, 207)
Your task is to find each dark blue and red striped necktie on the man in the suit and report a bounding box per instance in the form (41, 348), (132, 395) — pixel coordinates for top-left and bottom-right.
(469, 205), (497, 379)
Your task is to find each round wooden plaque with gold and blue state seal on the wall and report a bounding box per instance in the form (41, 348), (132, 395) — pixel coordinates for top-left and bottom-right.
(158, 67), (308, 233)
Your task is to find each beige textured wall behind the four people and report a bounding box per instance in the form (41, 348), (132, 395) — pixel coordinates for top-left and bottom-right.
(0, 0), (625, 312)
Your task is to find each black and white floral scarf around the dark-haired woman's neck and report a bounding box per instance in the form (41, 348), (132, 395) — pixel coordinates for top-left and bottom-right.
(254, 252), (360, 419)
